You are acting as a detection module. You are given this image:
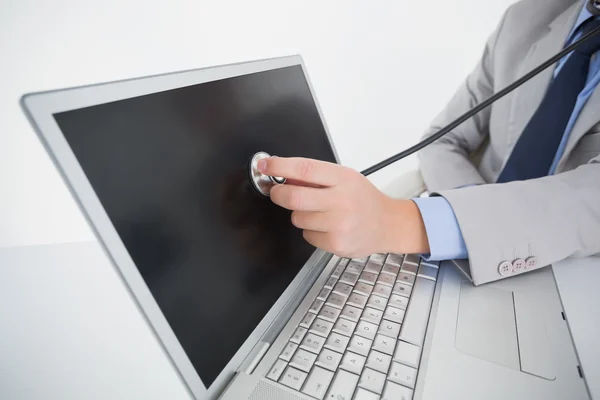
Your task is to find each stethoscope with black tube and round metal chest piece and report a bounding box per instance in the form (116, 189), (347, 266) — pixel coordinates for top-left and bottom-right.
(248, 0), (600, 196)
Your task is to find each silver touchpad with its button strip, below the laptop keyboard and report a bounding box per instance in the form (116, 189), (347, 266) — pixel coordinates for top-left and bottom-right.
(455, 281), (556, 379)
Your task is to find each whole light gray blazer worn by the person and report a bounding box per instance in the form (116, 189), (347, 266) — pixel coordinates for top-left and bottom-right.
(419, 0), (600, 285)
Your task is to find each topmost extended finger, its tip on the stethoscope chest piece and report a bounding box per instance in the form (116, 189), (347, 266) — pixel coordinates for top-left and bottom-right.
(258, 157), (342, 186)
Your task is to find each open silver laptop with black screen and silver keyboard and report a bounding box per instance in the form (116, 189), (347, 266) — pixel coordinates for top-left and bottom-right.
(22, 56), (600, 400)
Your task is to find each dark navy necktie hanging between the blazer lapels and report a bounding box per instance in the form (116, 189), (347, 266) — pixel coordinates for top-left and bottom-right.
(498, 20), (600, 182)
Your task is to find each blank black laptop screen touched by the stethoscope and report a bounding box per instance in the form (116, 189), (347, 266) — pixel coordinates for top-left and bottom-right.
(54, 65), (335, 387)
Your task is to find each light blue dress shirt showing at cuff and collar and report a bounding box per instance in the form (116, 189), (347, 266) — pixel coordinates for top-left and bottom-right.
(413, 2), (600, 261)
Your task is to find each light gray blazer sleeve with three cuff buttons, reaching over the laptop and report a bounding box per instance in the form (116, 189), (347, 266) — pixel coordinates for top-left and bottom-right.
(437, 156), (600, 285)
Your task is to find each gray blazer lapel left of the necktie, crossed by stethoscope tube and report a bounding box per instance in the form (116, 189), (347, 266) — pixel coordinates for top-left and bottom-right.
(505, 1), (581, 152)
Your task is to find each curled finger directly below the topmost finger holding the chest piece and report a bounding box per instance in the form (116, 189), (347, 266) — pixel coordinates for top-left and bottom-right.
(271, 185), (334, 211)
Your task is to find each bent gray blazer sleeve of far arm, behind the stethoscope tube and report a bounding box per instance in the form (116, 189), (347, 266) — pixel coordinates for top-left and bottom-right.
(418, 8), (510, 193)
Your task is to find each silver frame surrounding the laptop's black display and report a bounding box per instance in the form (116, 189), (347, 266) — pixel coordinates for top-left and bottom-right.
(21, 55), (339, 399)
